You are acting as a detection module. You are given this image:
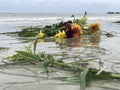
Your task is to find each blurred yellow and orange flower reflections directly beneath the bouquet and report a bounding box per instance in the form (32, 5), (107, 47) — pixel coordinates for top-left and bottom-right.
(56, 35), (100, 47)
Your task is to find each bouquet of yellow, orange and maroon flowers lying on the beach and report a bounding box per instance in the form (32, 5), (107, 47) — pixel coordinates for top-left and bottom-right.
(38, 14), (100, 38)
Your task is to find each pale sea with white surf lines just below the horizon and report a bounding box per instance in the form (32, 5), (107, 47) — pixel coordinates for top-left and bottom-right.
(0, 13), (120, 22)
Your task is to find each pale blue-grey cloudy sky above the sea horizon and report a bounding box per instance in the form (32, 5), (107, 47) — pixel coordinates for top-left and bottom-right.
(0, 0), (120, 13)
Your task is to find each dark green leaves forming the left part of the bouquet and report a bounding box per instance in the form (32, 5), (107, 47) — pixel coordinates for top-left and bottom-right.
(16, 22), (63, 37)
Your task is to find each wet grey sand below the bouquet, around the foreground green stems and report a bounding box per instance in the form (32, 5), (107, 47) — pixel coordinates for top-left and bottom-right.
(0, 35), (120, 90)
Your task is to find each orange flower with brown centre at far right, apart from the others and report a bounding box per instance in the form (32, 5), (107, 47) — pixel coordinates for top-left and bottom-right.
(88, 22), (100, 34)
